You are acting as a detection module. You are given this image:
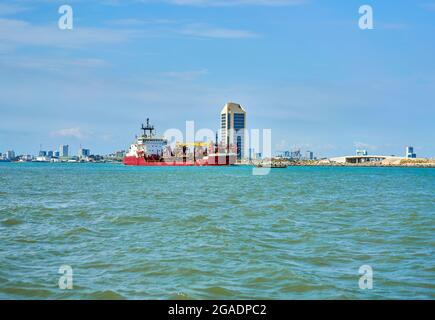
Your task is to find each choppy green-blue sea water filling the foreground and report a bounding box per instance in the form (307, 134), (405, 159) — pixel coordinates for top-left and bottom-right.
(0, 163), (435, 299)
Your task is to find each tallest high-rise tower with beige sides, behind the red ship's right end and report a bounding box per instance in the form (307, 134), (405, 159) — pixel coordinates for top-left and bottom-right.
(221, 102), (246, 160)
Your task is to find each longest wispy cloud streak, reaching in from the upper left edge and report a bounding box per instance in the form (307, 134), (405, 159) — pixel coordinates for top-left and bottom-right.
(0, 18), (258, 49)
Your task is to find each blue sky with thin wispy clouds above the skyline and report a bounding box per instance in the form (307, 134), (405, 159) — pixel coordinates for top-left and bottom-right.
(0, 0), (435, 157)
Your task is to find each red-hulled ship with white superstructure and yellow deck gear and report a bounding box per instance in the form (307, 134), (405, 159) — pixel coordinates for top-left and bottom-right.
(123, 119), (237, 166)
